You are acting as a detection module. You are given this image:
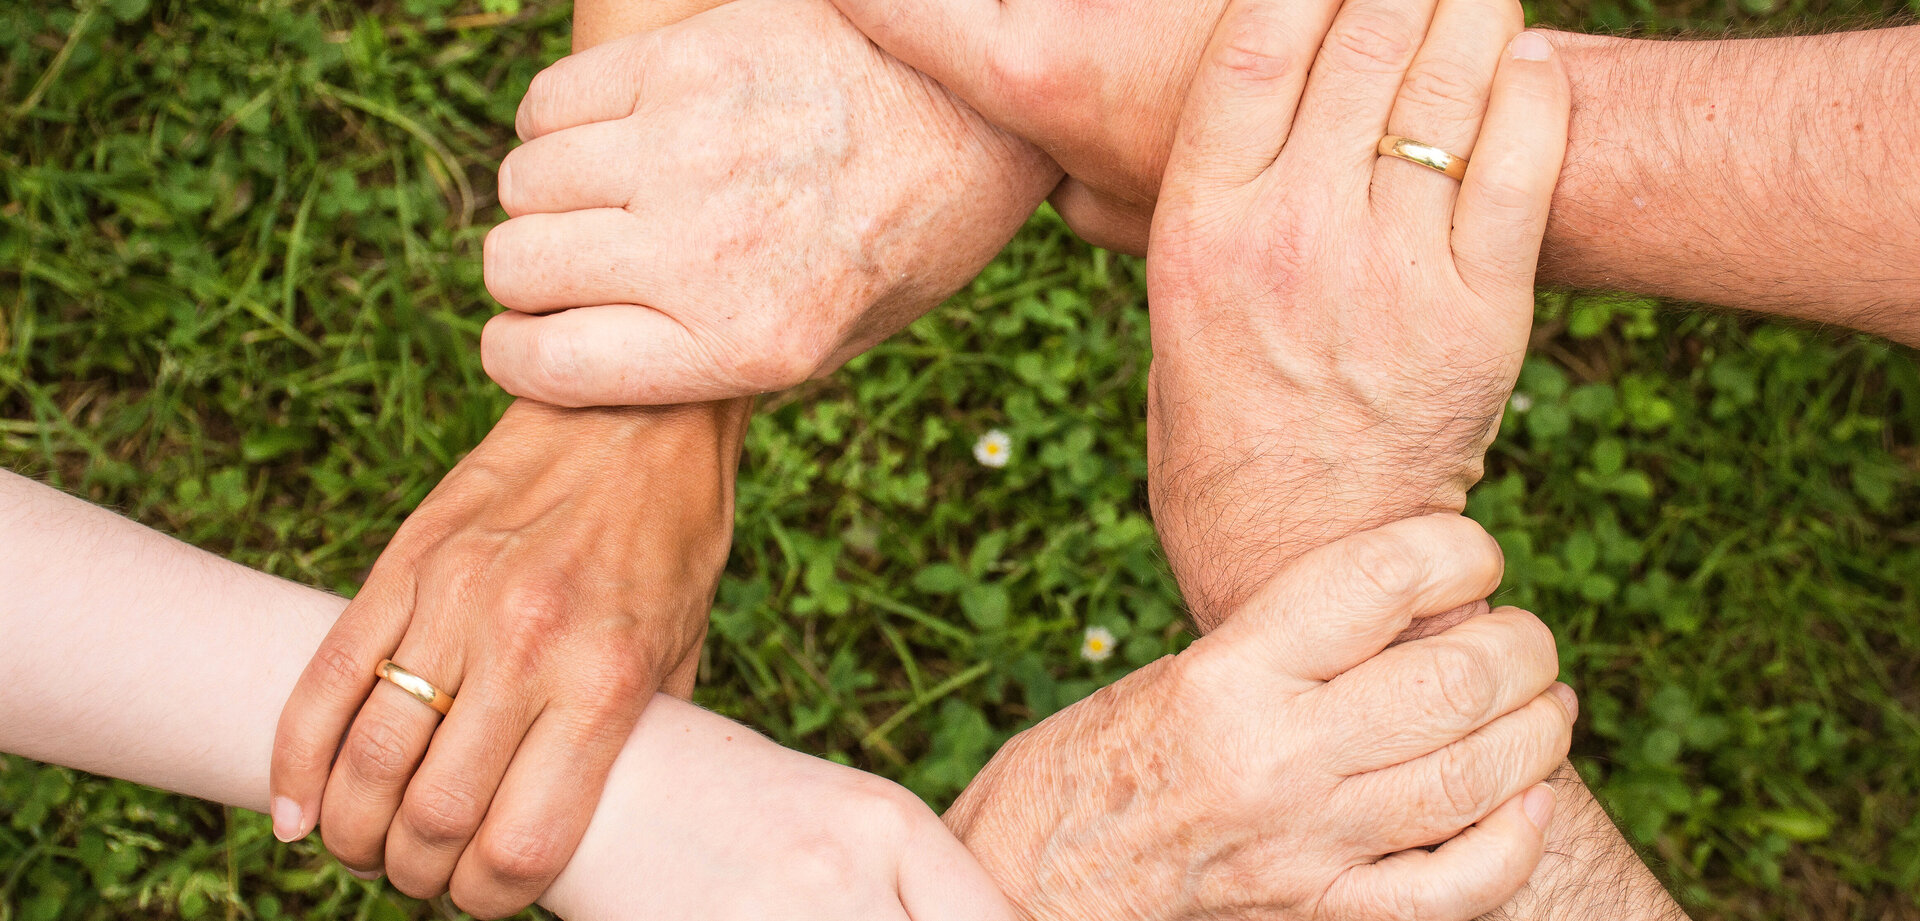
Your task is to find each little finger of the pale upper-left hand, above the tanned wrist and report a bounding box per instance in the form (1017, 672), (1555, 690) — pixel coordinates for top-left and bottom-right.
(480, 305), (768, 407)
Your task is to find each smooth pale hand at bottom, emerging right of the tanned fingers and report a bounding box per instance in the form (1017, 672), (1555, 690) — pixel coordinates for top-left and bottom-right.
(541, 698), (1014, 921)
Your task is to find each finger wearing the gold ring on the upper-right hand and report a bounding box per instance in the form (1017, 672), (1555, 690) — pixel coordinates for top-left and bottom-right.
(1373, 0), (1526, 224)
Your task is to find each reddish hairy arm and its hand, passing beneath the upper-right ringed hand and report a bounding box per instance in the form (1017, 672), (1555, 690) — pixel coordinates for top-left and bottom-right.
(837, 0), (1920, 345)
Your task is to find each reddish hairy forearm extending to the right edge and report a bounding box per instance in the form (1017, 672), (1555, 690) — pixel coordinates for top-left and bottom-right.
(1542, 27), (1920, 343)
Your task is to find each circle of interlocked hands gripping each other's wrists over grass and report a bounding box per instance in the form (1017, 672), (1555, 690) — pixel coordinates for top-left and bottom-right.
(273, 0), (1578, 921)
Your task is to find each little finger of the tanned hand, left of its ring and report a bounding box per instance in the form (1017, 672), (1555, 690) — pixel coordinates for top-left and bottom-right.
(269, 579), (413, 840)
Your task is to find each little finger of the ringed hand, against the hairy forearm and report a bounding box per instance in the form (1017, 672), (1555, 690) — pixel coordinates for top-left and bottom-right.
(1453, 33), (1572, 297)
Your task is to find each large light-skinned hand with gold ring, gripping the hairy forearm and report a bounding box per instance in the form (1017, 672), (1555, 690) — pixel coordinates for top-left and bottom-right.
(1146, 0), (1569, 622)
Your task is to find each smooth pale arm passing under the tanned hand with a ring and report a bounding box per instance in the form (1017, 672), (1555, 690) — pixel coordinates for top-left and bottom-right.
(0, 472), (1006, 921)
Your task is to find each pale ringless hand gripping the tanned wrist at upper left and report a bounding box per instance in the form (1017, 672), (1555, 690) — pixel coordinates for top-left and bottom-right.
(482, 0), (1058, 405)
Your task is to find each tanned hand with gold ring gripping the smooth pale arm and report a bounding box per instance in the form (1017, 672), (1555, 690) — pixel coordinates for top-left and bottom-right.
(273, 401), (745, 917)
